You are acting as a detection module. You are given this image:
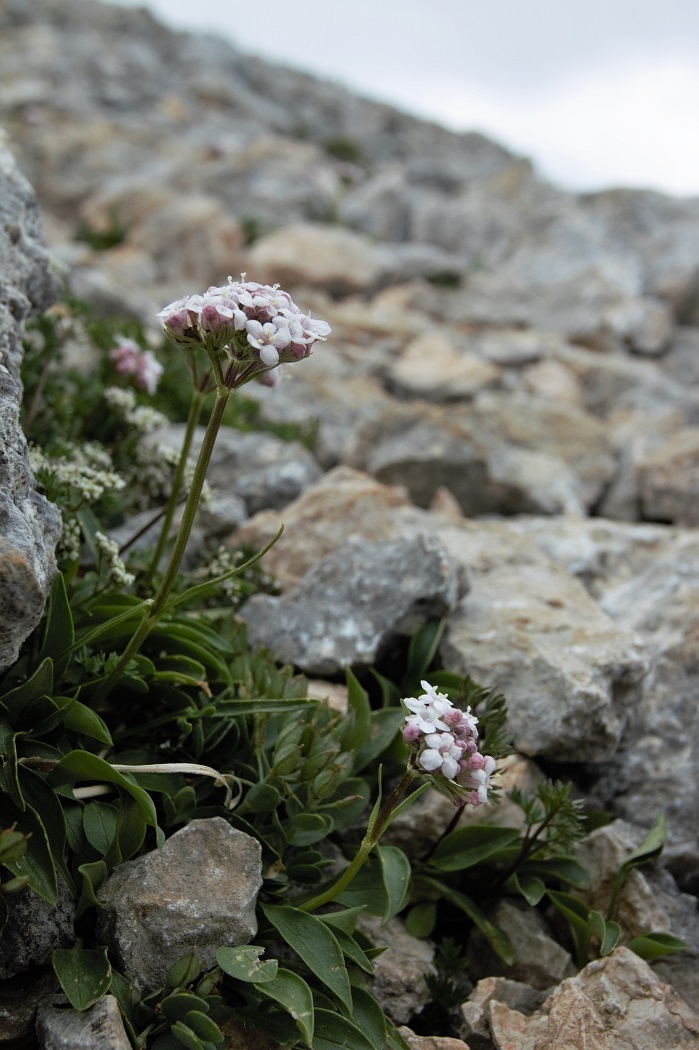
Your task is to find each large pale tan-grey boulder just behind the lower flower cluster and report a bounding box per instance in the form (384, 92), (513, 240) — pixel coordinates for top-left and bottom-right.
(441, 561), (648, 762)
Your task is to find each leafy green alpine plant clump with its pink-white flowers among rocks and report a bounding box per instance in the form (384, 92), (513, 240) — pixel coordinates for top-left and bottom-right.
(0, 275), (681, 1050)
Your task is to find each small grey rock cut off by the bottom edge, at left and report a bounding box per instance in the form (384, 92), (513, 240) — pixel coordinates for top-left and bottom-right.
(37, 995), (131, 1050)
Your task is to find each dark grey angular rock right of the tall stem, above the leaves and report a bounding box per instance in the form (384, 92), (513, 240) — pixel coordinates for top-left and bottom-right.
(240, 536), (464, 674)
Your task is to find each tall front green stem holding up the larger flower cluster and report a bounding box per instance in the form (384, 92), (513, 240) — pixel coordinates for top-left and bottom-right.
(94, 385), (231, 702)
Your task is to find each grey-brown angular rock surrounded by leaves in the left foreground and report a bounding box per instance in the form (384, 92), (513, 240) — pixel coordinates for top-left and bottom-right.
(98, 817), (262, 990)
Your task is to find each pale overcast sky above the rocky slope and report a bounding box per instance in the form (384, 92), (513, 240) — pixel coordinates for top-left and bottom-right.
(111, 0), (699, 195)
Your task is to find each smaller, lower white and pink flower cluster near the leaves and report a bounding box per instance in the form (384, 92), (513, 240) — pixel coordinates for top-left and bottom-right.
(401, 681), (495, 805)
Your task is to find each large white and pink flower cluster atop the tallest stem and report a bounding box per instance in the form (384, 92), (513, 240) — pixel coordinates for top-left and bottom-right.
(157, 274), (331, 382)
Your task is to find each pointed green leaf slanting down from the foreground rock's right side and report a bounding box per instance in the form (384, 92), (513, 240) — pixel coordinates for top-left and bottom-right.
(262, 904), (352, 1009)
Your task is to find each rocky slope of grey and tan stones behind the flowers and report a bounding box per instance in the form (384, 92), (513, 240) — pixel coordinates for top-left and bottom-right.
(0, 0), (699, 1050)
